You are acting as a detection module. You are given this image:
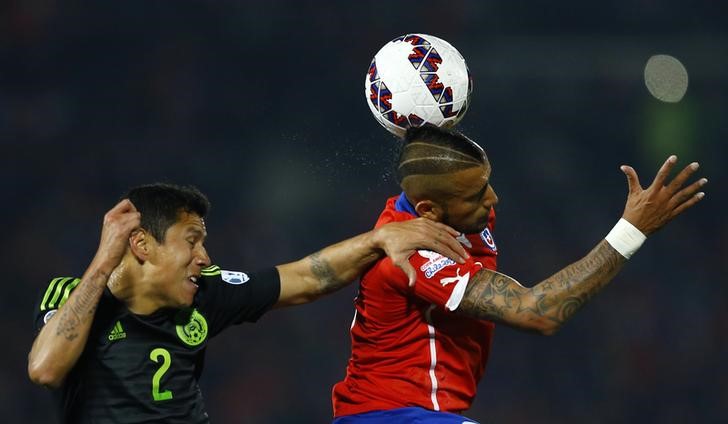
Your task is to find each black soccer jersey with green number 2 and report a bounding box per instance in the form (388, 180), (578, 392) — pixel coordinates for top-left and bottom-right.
(35, 266), (280, 424)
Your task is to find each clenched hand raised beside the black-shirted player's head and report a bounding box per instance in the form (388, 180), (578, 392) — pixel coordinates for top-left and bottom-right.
(94, 199), (141, 272)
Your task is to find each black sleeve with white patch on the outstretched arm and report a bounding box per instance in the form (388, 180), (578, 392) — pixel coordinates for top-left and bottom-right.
(197, 268), (281, 336)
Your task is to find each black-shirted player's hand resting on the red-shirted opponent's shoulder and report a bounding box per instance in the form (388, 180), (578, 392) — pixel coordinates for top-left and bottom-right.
(376, 218), (468, 287)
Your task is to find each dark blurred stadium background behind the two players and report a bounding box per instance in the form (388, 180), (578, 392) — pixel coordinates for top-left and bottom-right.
(0, 0), (728, 423)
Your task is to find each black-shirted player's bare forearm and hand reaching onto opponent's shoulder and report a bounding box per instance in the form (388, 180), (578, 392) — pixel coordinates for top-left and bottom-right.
(276, 218), (467, 307)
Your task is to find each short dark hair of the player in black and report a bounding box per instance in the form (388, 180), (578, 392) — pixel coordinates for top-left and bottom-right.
(124, 183), (210, 243)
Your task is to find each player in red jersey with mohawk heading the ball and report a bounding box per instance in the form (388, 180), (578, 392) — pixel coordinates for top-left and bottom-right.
(333, 125), (707, 424)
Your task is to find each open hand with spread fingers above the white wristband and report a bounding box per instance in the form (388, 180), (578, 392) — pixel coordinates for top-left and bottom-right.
(620, 155), (708, 235)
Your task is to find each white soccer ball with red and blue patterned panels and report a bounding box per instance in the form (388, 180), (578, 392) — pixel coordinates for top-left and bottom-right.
(364, 34), (473, 137)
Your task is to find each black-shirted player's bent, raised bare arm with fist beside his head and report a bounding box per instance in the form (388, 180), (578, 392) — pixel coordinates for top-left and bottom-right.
(28, 199), (141, 387)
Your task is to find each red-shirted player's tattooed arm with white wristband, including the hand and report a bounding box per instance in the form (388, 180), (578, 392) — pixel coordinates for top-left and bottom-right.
(458, 156), (707, 334)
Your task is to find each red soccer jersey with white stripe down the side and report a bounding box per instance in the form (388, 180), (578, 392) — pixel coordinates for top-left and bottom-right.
(332, 195), (497, 417)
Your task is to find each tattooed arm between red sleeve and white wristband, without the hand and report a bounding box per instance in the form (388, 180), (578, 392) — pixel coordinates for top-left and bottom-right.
(459, 240), (626, 333)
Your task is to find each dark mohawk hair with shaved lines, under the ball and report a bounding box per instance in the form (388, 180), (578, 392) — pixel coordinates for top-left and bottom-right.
(397, 124), (488, 182)
